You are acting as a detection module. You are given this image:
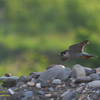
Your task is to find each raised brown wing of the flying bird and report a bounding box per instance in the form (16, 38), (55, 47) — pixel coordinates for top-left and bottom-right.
(68, 40), (89, 53)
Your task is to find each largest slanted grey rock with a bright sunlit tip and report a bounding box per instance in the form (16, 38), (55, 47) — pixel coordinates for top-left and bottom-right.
(37, 65), (65, 83)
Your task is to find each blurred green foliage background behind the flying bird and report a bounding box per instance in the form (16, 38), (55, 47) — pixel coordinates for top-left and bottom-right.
(0, 0), (100, 76)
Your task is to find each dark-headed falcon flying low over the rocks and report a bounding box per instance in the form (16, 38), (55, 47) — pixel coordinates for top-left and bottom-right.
(59, 40), (97, 61)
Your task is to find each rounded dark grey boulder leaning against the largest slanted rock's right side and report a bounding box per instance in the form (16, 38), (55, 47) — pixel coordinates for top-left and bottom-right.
(57, 68), (71, 81)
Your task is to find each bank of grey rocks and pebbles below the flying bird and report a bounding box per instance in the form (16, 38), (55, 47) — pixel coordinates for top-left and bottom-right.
(0, 64), (100, 100)
